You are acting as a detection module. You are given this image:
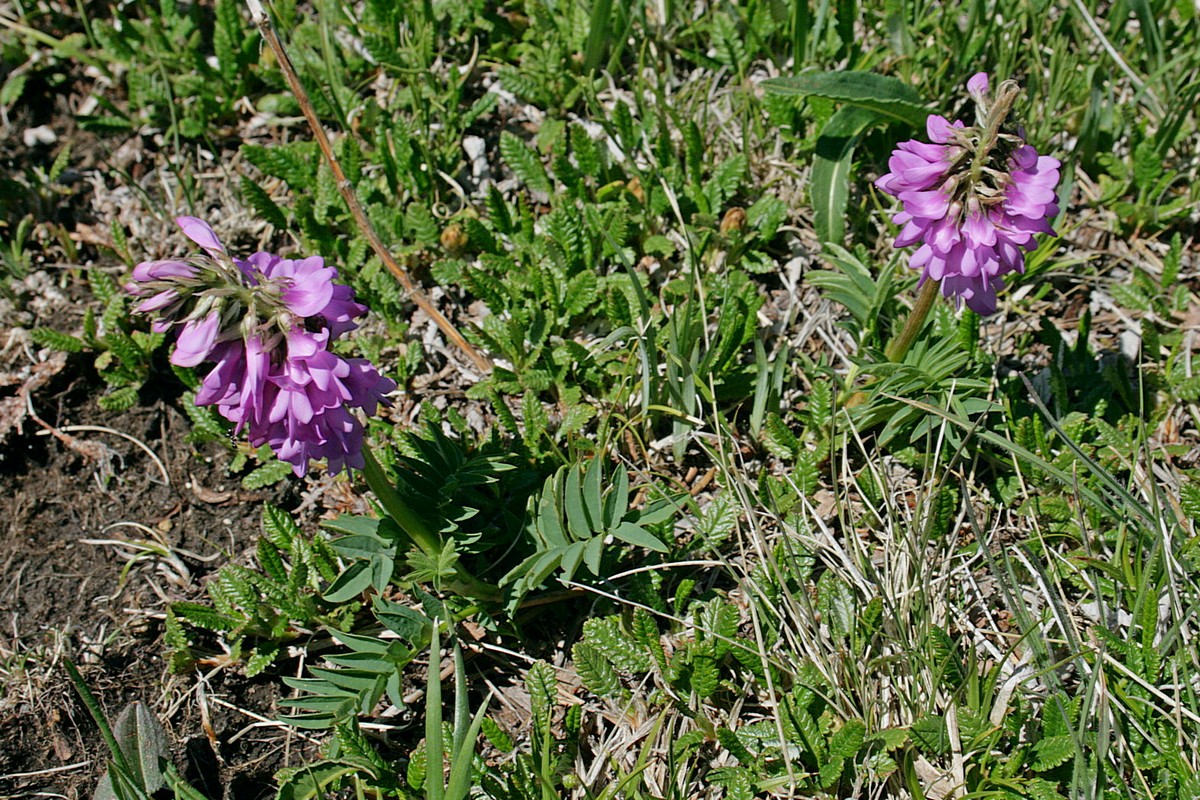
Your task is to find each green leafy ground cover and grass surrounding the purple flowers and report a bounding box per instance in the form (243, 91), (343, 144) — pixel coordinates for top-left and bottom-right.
(0, 0), (1200, 800)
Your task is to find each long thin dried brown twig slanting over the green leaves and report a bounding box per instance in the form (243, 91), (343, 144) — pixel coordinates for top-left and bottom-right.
(246, 0), (492, 374)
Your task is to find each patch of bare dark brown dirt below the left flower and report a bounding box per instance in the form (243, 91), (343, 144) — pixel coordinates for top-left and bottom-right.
(0, 355), (312, 800)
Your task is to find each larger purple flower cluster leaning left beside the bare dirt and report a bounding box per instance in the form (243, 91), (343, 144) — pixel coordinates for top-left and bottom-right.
(126, 217), (396, 475)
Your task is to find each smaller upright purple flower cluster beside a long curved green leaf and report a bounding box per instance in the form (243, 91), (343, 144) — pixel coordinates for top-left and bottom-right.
(875, 72), (1060, 315)
